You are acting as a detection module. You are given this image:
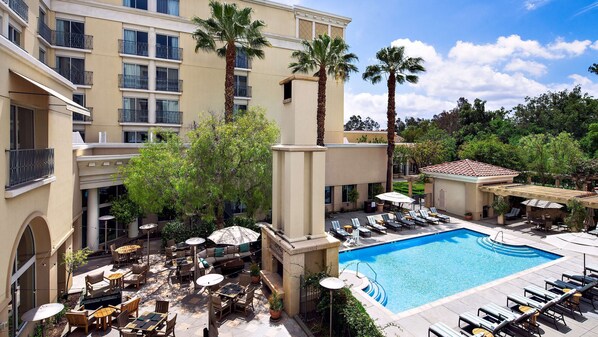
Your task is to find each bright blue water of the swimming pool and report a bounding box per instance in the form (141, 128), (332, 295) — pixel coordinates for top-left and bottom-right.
(339, 229), (561, 313)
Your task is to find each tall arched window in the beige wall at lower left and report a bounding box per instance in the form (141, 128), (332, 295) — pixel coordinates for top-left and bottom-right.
(8, 226), (35, 337)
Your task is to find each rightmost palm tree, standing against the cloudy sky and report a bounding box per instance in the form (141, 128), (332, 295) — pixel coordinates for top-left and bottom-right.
(362, 46), (426, 192)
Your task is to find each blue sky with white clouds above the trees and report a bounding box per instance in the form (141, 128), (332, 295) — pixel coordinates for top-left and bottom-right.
(278, 0), (598, 129)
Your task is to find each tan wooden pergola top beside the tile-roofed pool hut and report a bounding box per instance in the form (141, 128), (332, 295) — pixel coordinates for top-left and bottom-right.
(480, 184), (598, 209)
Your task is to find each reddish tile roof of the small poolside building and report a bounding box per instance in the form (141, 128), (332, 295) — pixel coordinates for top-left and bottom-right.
(420, 159), (519, 177)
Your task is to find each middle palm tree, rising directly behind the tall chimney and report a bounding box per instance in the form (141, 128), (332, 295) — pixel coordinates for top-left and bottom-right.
(289, 34), (358, 146)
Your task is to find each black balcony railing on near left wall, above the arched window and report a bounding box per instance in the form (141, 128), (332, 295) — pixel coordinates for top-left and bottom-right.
(6, 149), (54, 187)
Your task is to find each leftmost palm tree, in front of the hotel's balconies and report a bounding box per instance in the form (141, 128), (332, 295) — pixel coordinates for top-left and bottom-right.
(192, 0), (270, 123)
